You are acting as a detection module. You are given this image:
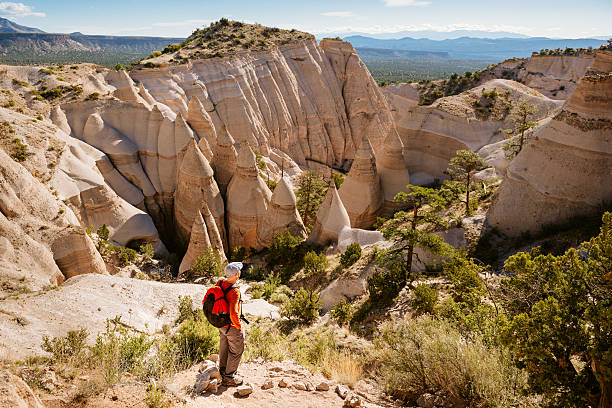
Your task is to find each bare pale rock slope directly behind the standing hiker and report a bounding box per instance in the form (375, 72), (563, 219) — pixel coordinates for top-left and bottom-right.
(0, 274), (278, 359)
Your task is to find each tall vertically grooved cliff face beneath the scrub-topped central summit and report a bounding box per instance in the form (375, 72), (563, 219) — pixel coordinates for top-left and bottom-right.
(131, 39), (392, 166)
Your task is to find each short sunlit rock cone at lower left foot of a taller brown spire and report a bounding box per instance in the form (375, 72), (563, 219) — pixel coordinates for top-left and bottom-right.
(308, 179), (351, 245)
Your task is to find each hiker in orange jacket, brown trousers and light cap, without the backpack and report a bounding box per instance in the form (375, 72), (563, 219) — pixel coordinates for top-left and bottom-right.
(217, 262), (244, 387)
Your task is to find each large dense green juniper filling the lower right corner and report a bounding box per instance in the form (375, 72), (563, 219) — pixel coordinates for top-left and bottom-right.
(502, 212), (612, 408)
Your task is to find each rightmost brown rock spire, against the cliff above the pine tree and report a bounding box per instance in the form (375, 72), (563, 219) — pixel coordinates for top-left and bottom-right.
(376, 129), (410, 217)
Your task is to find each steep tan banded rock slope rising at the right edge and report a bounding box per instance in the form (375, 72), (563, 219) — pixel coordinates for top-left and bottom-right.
(488, 50), (612, 235)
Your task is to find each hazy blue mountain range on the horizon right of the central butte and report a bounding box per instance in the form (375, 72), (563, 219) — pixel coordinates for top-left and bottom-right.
(343, 36), (606, 60)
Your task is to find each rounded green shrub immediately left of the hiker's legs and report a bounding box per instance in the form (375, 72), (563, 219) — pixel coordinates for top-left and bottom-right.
(172, 319), (219, 367)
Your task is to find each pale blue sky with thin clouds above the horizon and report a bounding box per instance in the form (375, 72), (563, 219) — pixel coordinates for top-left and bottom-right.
(0, 0), (612, 38)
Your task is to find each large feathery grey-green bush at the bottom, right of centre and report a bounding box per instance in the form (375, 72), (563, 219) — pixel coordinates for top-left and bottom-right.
(374, 316), (527, 407)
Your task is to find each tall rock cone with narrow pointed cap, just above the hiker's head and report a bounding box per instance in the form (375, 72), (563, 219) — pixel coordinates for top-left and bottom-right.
(226, 141), (272, 249)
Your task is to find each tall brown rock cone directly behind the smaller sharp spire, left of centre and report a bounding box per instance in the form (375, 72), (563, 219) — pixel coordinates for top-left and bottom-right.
(174, 139), (225, 249)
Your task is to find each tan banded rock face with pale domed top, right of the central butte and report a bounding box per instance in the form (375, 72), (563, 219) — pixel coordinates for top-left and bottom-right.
(389, 79), (563, 185)
